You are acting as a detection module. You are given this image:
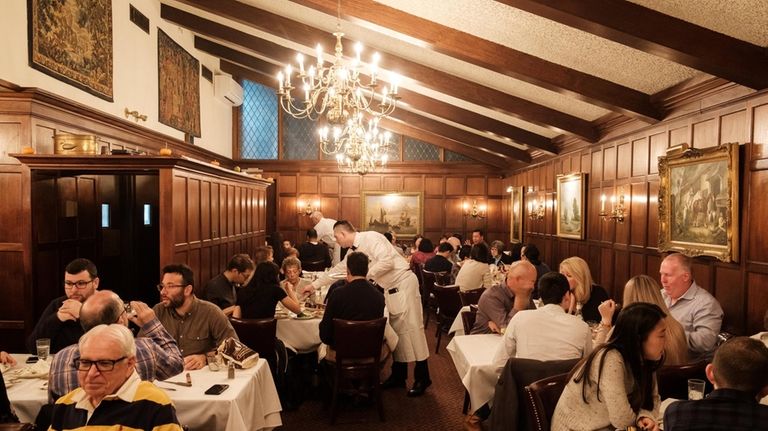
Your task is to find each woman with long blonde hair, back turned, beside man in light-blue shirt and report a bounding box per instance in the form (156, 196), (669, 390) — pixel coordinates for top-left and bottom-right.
(595, 275), (688, 365)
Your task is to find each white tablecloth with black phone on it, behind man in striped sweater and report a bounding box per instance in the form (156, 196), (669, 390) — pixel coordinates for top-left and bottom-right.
(8, 355), (282, 431)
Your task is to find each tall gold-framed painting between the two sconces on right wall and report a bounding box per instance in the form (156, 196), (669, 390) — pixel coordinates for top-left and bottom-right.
(556, 173), (586, 239)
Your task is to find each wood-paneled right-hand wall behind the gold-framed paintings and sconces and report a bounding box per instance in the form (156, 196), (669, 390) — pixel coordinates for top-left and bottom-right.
(507, 92), (768, 334)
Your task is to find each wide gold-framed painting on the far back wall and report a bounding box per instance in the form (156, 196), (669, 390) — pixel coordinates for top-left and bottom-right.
(360, 192), (424, 235)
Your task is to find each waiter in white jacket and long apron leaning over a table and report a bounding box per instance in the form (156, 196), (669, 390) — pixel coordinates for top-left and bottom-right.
(305, 220), (432, 397)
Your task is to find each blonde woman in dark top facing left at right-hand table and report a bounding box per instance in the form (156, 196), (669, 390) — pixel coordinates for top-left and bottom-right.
(560, 256), (609, 322)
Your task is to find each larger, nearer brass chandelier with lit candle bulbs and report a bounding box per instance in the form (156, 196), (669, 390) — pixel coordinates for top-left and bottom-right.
(277, 26), (399, 125)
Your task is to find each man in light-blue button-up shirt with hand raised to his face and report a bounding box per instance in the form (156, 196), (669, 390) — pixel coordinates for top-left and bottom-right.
(659, 253), (723, 362)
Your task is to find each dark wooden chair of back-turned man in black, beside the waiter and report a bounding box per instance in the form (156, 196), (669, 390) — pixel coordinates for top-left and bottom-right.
(331, 317), (387, 425)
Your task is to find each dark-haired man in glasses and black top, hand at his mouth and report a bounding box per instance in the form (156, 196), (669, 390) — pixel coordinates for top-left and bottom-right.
(27, 258), (99, 354)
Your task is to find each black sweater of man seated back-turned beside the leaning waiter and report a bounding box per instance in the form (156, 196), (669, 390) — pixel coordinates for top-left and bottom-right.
(320, 279), (384, 347)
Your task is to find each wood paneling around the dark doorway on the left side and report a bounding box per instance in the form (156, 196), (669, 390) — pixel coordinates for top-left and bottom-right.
(0, 84), (269, 351)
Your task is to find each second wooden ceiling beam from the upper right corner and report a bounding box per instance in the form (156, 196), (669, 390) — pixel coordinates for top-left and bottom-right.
(291, 0), (664, 123)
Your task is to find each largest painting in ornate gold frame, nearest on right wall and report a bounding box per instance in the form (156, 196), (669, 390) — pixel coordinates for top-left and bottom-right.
(659, 143), (739, 262)
